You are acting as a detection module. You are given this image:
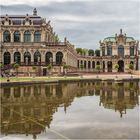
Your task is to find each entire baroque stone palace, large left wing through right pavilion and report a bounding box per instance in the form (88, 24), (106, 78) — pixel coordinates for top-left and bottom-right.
(0, 8), (139, 75)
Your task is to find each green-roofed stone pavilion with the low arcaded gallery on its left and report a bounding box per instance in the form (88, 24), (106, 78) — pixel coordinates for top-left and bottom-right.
(78, 30), (139, 72)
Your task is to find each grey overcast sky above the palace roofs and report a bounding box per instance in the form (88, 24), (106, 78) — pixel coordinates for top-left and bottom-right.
(1, 0), (140, 49)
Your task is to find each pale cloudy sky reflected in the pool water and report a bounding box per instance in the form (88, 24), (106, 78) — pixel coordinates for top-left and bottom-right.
(2, 81), (140, 140)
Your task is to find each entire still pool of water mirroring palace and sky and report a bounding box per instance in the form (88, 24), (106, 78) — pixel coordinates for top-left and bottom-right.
(1, 81), (140, 140)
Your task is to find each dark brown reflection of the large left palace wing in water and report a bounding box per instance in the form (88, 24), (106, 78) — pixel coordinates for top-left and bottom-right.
(1, 84), (75, 138)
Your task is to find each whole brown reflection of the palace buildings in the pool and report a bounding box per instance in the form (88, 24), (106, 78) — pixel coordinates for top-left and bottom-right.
(1, 82), (139, 138)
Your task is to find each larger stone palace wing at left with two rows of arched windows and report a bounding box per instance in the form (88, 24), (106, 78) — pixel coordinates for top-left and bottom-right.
(0, 9), (77, 75)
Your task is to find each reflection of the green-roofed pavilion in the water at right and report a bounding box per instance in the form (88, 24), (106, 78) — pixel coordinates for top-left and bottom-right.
(100, 82), (139, 117)
